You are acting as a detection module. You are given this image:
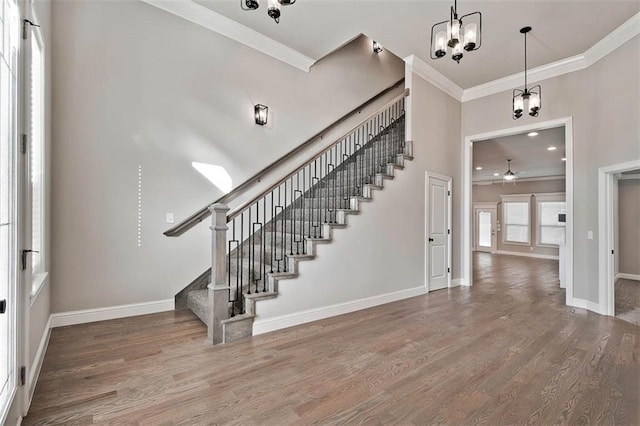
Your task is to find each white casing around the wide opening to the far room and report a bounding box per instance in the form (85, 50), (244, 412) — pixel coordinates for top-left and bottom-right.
(461, 116), (581, 307)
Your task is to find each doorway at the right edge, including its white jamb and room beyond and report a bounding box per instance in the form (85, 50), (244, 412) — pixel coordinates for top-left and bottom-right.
(598, 160), (640, 325)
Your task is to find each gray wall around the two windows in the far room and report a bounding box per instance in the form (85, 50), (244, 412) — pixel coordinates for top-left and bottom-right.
(471, 179), (565, 256)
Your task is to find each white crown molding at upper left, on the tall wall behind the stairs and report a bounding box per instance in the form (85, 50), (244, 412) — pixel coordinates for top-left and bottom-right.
(141, 0), (316, 72)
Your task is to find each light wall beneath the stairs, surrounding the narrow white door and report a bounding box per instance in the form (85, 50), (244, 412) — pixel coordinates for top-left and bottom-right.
(256, 73), (461, 330)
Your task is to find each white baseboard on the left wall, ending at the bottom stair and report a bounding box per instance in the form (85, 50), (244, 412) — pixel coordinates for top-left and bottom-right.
(51, 299), (175, 327)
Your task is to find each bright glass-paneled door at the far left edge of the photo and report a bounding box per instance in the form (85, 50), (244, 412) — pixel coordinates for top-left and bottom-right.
(0, 0), (20, 423)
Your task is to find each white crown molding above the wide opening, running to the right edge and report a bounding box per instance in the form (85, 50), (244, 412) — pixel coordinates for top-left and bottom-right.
(462, 13), (640, 102)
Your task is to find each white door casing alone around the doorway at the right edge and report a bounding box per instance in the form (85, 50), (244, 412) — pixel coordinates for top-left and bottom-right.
(598, 159), (640, 316)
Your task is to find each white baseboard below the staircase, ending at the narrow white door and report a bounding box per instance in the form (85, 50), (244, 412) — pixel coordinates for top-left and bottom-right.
(253, 286), (426, 336)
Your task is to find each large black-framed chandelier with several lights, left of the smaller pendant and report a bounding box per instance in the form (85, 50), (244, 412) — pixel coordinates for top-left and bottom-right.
(429, 0), (482, 63)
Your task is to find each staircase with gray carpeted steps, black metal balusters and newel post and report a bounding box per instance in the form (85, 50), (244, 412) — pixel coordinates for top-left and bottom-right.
(172, 90), (413, 343)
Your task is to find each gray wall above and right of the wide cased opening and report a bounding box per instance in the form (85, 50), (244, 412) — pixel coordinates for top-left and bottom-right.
(462, 36), (640, 303)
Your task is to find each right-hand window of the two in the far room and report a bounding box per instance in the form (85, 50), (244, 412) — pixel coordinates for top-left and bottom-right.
(535, 192), (566, 246)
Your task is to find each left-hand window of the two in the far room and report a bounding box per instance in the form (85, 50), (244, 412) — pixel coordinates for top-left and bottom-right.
(500, 194), (531, 245)
